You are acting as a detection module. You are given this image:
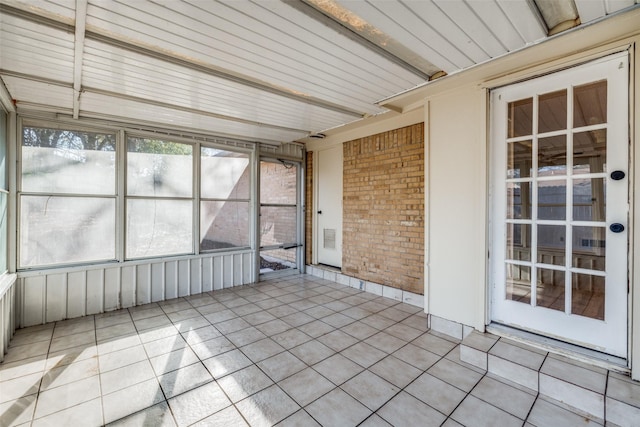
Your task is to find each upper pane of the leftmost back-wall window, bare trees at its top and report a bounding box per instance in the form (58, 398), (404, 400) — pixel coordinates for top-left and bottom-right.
(21, 127), (116, 195)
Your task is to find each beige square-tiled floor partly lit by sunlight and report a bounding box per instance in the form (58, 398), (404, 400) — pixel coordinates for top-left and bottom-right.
(0, 275), (632, 427)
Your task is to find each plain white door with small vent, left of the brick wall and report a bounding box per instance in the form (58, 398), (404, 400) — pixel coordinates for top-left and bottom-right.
(316, 145), (342, 267)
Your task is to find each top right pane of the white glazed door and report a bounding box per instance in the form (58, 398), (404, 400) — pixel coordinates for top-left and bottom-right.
(573, 80), (607, 128)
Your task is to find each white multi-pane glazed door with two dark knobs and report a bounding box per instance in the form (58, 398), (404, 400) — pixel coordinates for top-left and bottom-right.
(490, 53), (629, 358)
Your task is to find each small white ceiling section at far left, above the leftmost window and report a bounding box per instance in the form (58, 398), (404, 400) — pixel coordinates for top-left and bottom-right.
(2, 75), (73, 109)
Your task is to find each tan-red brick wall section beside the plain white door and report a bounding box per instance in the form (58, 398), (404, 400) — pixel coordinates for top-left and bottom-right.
(342, 123), (424, 294)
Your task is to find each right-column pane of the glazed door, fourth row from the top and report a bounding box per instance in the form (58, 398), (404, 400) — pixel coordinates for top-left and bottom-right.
(572, 227), (607, 271)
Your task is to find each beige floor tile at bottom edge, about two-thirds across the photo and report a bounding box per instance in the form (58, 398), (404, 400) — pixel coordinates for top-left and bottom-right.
(377, 391), (446, 427)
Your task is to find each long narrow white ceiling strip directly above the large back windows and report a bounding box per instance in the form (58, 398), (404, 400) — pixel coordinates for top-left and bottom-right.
(80, 92), (307, 144)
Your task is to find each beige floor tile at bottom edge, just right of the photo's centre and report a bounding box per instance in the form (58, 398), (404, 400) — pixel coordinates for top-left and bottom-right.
(305, 388), (372, 426)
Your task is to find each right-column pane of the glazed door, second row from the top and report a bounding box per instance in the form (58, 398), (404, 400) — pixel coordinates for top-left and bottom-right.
(573, 129), (607, 175)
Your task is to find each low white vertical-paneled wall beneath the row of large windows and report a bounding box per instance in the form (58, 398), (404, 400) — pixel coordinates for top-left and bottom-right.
(16, 250), (255, 330)
